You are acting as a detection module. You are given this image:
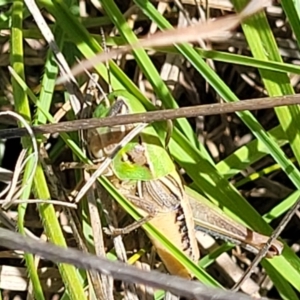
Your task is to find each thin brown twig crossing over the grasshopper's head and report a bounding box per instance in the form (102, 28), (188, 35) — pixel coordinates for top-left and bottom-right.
(0, 94), (300, 139)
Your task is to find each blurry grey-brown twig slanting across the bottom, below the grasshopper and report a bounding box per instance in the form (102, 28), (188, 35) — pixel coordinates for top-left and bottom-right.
(0, 228), (258, 300)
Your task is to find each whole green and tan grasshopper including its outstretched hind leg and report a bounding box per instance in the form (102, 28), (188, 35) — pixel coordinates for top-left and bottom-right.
(88, 91), (283, 278)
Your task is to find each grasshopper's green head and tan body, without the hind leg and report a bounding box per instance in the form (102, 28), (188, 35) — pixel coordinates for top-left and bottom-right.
(88, 91), (200, 278)
